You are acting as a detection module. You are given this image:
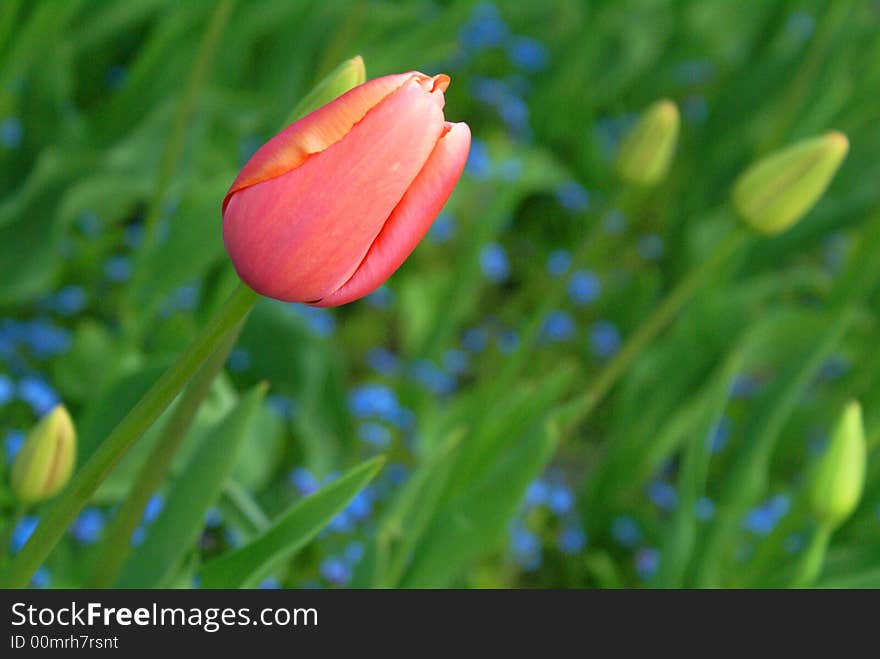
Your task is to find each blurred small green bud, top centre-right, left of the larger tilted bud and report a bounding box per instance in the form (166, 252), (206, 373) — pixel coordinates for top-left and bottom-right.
(617, 99), (680, 186)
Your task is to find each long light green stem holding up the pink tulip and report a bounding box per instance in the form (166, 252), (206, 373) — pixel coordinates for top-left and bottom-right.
(4, 283), (259, 588)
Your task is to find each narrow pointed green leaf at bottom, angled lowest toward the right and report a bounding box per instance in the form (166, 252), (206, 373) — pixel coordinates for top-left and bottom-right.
(202, 457), (384, 588)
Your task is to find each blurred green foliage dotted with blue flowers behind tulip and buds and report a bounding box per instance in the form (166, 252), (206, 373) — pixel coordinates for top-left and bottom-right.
(0, 0), (880, 587)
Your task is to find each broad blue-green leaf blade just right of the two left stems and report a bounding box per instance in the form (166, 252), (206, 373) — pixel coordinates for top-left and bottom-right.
(117, 385), (266, 588)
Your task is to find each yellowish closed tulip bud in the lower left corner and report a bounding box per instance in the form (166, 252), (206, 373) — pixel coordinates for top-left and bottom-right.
(12, 405), (76, 502)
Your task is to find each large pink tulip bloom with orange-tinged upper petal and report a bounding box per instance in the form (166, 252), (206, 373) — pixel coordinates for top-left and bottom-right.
(223, 72), (471, 307)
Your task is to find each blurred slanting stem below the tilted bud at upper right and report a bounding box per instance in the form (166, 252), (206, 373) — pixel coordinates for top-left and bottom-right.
(559, 225), (749, 436)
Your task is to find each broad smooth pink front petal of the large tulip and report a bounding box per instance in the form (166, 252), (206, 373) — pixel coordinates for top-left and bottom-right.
(223, 76), (446, 302)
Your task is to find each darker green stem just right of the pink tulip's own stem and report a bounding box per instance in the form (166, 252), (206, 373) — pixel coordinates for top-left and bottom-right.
(90, 323), (241, 588)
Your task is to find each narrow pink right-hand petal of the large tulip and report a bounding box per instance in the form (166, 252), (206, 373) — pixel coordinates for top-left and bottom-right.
(314, 123), (471, 307)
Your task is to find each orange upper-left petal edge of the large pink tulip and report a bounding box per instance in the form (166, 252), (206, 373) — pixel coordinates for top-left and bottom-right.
(223, 71), (449, 211)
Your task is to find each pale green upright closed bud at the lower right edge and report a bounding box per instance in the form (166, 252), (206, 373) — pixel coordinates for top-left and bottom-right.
(810, 401), (867, 528)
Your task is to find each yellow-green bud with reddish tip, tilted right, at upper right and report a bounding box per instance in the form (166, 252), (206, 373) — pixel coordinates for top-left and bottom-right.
(733, 131), (849, 235)
